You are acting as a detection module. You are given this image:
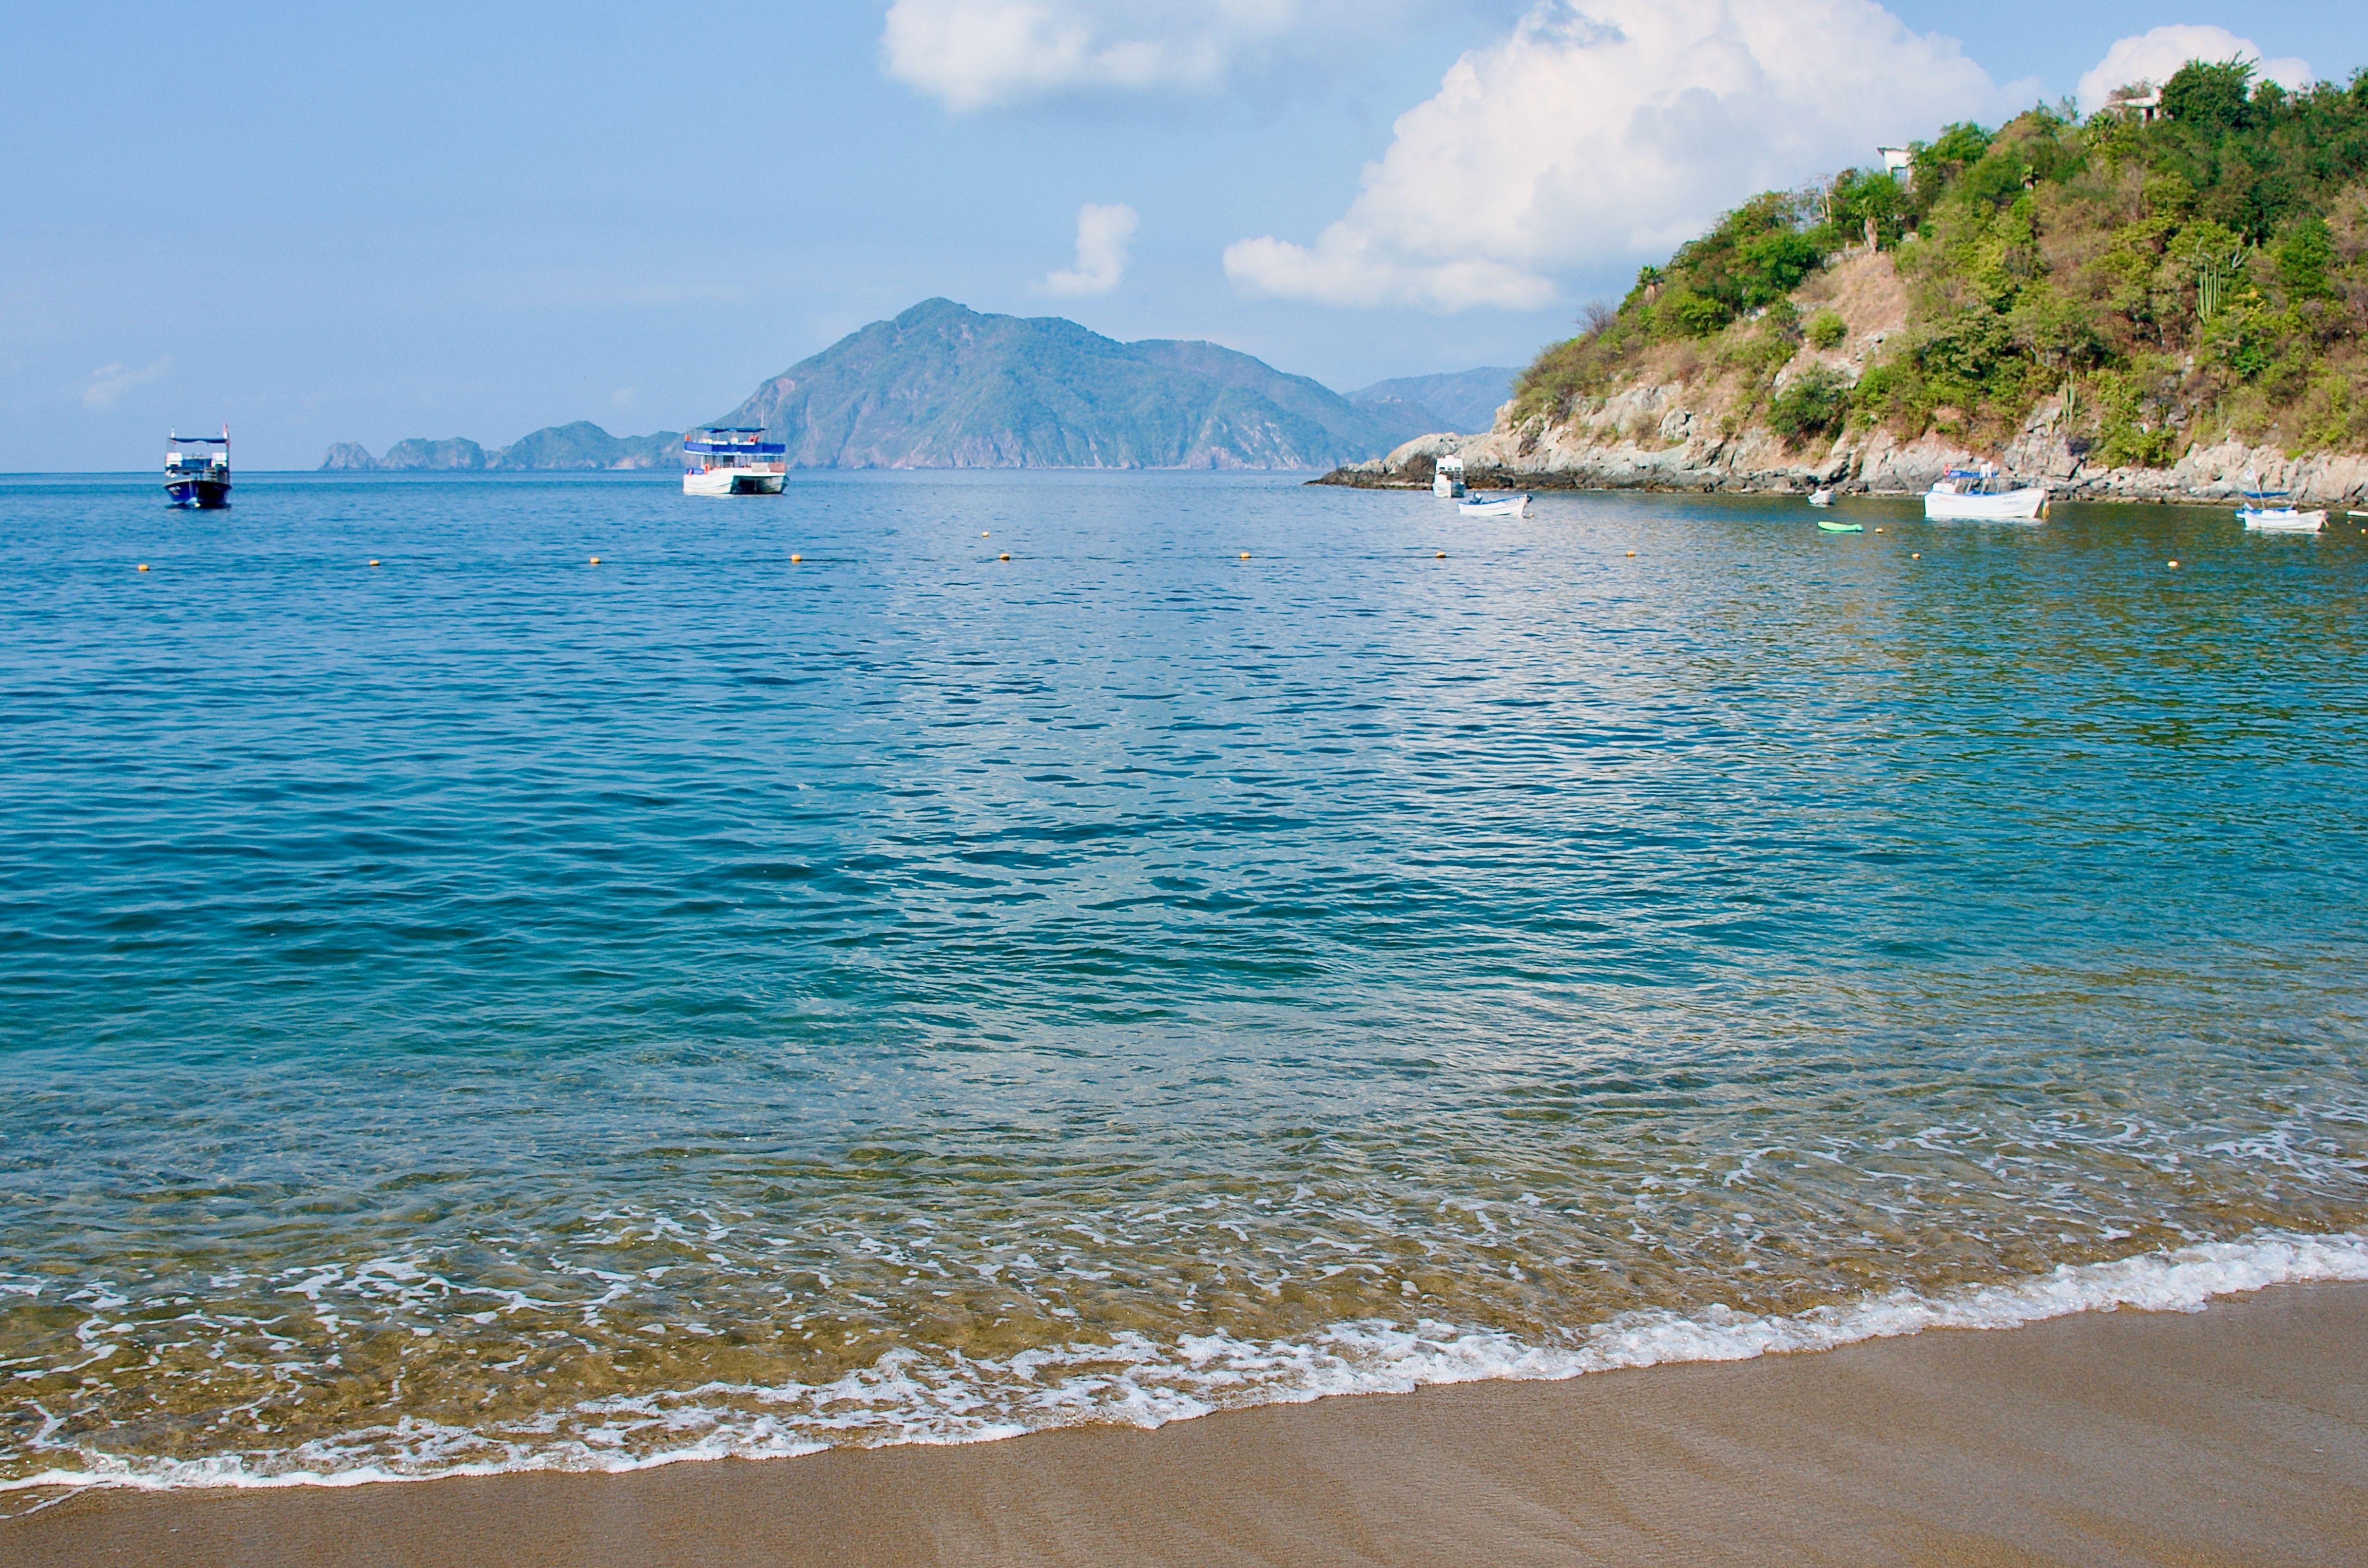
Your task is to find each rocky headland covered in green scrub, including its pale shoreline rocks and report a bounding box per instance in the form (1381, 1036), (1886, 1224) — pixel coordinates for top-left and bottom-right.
(1328, 61), (2368, 504)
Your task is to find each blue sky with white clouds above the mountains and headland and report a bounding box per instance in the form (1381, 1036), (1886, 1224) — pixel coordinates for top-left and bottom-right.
(0, 0), (2368, 471)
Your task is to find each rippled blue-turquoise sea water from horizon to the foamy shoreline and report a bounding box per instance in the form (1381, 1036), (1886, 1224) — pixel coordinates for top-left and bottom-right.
(0, 474), (2368, 1483)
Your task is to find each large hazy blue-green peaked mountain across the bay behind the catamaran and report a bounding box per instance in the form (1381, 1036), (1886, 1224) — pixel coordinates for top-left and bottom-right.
(717, 298), (1433, 469)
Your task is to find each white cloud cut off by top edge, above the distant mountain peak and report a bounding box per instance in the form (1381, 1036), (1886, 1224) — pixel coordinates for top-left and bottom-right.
(881, 0), (1406, 111)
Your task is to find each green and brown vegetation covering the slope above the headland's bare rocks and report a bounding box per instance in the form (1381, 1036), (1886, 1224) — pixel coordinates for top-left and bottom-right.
(1518, 61), (2368, 467)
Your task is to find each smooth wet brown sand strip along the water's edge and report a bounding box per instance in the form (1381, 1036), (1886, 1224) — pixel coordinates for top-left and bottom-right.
(0, 1286), (2368, 1568)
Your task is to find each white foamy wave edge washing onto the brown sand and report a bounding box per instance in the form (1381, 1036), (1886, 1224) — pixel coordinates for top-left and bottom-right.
(0, 1232), (2368, 1492)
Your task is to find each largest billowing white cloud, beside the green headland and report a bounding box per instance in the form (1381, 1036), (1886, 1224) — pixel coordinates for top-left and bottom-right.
(1224, 0), (2034, 310)
